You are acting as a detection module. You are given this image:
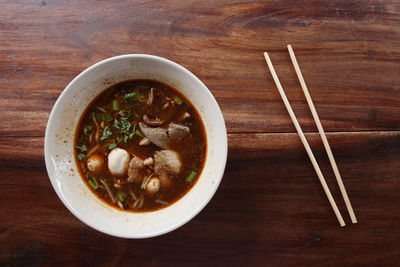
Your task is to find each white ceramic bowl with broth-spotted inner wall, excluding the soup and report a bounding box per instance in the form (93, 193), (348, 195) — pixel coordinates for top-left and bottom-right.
(44, 54), (228, 238)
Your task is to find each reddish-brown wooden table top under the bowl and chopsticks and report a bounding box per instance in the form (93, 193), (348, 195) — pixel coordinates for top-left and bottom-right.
(0, 0), (400, 266)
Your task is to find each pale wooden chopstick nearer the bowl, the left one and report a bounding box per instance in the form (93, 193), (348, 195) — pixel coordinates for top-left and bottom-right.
(264, 52), (346, 227)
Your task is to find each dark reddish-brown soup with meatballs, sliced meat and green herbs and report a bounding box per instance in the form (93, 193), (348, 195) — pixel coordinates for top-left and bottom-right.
(75, 80), (206, 212)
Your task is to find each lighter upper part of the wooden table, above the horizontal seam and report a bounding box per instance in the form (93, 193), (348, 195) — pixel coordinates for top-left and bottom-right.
(0, 0), (400, 136)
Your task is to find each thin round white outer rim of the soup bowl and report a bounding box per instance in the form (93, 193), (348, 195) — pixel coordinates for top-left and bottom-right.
(44, 54), (228, 239)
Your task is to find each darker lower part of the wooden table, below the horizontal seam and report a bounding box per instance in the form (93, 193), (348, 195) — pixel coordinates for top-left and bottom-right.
(0, 132), (400, 266)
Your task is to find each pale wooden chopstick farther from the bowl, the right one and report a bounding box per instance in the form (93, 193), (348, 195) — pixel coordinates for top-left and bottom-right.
(287, 45), (357, 223)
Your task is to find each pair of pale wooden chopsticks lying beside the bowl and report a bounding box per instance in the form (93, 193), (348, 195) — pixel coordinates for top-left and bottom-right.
(264, 45), (357, 227)
